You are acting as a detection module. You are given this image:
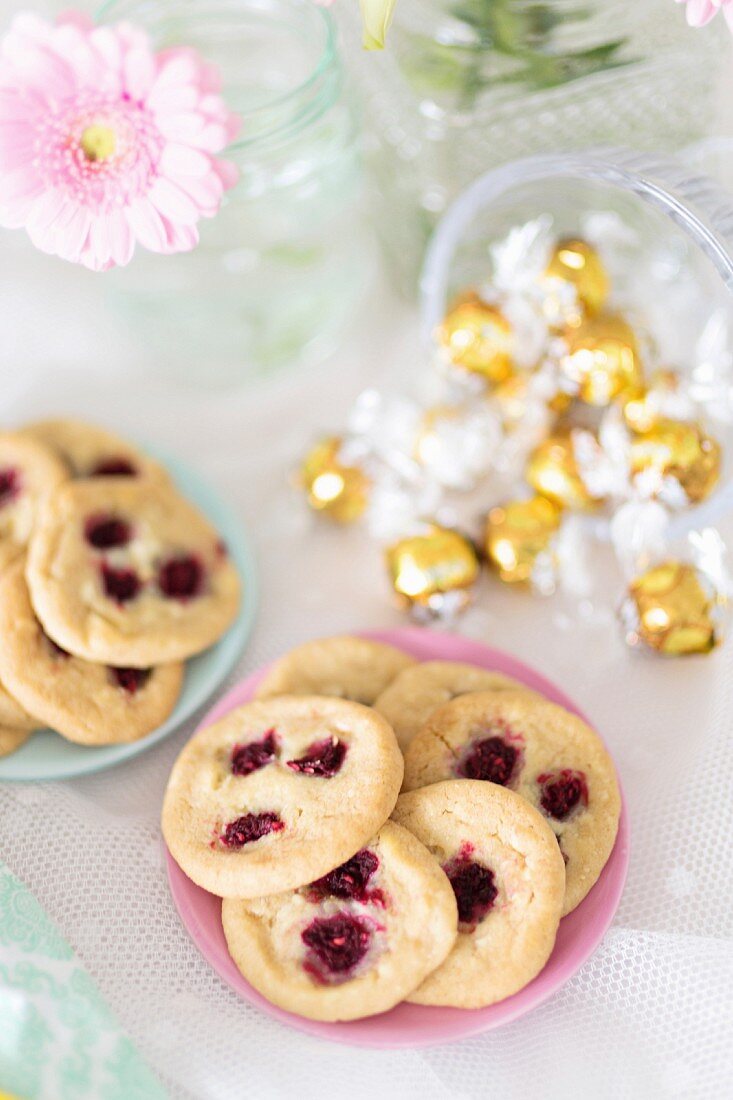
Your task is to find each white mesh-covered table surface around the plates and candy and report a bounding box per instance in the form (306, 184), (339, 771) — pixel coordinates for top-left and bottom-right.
(0, 2), (733, 1100)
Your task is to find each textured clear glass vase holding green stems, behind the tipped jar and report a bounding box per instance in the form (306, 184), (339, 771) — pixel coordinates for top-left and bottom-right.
(344, 0), (727, 290)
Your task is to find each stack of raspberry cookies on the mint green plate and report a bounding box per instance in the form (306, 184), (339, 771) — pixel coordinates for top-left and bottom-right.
(0, 420), (240, 756)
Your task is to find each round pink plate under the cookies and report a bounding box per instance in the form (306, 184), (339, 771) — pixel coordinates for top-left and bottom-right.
(166, 627), (628, 1049)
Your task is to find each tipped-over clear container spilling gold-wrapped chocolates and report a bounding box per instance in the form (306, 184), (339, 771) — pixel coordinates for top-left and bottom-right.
(420, 149), (733, 540)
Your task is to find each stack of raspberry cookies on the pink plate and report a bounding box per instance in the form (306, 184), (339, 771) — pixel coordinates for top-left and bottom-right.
(163, 637), (621, 1021)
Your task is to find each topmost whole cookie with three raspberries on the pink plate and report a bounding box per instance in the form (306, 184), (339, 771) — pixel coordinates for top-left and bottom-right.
(163, 695), (403, 898)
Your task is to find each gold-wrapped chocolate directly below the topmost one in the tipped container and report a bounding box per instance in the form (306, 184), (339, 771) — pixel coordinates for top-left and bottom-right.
(560, 314), (644, 408)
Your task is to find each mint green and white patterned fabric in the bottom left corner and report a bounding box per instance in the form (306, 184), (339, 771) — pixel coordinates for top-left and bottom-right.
(0, 862), (166, 1100)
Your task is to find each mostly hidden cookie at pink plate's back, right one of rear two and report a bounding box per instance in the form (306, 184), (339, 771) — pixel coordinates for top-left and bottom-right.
(374, 661), (530, 751)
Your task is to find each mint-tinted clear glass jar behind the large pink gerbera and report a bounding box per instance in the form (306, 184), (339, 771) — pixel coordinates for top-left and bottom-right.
(99, 0), (373, 385)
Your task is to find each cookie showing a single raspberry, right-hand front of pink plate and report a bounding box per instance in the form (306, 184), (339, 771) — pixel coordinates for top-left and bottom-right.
(393, 780), (565, 1009)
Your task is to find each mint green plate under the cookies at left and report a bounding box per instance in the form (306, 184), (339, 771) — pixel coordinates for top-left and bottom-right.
(0, 447), (258, 781)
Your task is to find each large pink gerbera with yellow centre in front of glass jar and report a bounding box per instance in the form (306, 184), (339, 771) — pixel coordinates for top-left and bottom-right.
(0, 14), (237, 271)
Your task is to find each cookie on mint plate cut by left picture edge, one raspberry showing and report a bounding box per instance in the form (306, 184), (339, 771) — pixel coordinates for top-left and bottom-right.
(0, 431), (68, 572)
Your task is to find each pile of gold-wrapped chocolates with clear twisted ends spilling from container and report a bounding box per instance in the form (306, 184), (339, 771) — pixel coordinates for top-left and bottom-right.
(300, 213), (733, 655)
